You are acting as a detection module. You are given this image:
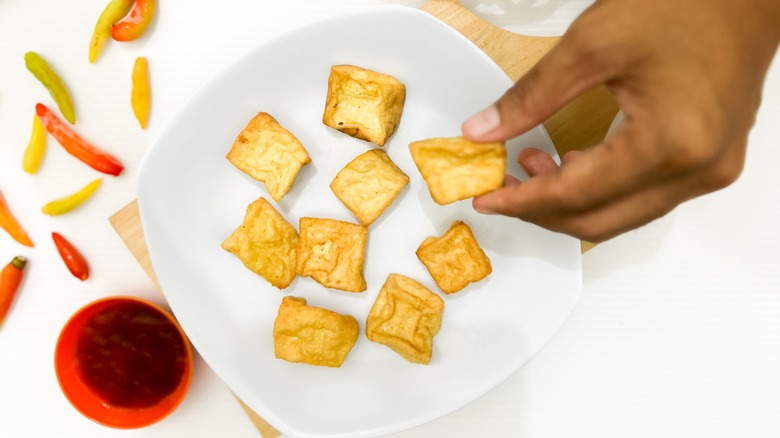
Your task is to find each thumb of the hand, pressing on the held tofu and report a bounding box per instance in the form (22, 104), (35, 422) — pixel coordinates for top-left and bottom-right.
(461, 23), (607, 142)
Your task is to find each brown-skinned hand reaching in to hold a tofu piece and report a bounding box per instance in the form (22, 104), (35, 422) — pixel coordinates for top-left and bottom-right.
(462, 0), (780, 242)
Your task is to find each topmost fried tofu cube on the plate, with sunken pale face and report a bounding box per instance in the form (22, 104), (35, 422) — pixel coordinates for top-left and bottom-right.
(322, 65), (406, 146)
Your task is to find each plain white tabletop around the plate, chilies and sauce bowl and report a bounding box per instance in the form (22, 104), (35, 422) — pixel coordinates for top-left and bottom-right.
(0, 0), (780, 437)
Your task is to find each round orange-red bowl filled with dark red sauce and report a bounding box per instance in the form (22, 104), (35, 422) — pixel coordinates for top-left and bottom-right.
(54, 296), (193, 429)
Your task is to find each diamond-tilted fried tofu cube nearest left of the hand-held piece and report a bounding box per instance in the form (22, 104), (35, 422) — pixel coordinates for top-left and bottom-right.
(330, 149), (409, 226)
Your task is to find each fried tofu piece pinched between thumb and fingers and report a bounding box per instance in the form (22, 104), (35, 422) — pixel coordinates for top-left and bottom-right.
(409, 137), (506, 205)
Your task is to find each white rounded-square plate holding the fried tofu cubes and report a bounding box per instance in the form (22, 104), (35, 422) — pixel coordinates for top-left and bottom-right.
(138, 8), (581, 437)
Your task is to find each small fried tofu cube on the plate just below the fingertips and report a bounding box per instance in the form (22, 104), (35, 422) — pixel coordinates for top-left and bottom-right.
(416, 221), (493, 294)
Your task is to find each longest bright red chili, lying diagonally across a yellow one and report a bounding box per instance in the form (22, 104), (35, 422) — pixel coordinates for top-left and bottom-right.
(35, 103), (124, 176)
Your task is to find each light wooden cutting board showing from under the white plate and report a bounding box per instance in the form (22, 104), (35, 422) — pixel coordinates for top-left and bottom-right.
(110, 0), (617, 438)
